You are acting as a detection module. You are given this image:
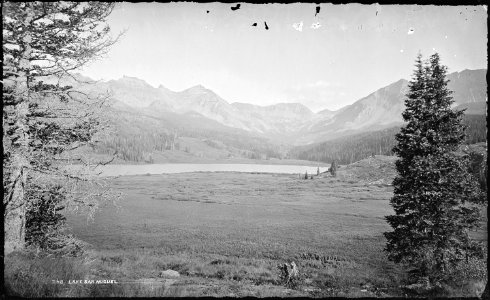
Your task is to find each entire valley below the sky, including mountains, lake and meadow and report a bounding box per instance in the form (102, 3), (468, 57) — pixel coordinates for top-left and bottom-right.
(6, 72), (487, 297)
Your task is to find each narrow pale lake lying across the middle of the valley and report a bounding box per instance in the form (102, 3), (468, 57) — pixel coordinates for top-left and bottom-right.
(97, 164), (328, 177)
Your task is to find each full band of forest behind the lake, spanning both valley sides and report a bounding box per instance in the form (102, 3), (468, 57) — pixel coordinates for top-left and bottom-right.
(96, 110), (486, 164)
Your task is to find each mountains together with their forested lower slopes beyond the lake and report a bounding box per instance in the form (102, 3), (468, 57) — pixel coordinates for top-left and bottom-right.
(61, 69), (486, 164)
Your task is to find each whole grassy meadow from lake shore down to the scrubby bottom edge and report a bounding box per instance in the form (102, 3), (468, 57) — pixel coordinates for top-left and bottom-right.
(7, 156), (486, 297)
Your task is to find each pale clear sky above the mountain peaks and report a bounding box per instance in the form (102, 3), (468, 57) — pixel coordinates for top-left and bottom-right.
(81, 2), (487, 112)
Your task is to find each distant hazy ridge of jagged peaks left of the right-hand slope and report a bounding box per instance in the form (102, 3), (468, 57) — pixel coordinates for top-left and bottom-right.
(89, 76), (322, 134)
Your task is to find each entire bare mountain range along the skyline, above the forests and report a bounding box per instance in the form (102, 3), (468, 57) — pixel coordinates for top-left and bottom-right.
(74, 69), (487, 145)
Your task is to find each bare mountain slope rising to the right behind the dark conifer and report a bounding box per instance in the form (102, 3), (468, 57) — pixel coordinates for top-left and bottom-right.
(292, 69), (487, 145)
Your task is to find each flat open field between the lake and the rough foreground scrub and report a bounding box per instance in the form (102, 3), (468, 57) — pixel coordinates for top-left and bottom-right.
(70, 173), (406, 296)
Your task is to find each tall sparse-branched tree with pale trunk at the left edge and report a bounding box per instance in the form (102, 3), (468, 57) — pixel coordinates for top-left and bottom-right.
(2, 1), (122, 254)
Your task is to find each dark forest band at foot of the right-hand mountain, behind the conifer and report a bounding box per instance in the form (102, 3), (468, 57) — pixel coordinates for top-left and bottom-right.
(290, 115), (487, 164)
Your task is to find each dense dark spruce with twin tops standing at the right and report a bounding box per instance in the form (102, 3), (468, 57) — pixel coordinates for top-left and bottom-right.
(385, 53), (483, 283)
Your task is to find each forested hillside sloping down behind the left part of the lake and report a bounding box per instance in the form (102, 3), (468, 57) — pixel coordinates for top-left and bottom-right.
(94, 111), (286, 163)
